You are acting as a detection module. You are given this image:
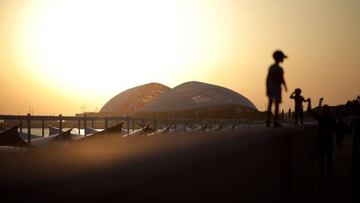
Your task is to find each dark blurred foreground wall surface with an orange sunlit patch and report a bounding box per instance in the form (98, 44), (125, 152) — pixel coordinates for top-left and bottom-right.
(0, 126), (352, 202)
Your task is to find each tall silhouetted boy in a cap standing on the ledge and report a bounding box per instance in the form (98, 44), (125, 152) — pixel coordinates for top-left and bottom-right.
(266, 50), (287, 127)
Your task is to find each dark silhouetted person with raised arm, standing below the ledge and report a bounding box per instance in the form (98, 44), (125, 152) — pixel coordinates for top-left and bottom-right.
(308, 99), (336, 179)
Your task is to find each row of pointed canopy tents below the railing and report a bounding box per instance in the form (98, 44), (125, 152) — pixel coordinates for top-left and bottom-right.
(0, 122), (242, 148)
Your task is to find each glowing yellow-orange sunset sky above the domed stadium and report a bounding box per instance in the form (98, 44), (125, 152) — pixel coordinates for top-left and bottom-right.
(0, 0), (360, 115)
